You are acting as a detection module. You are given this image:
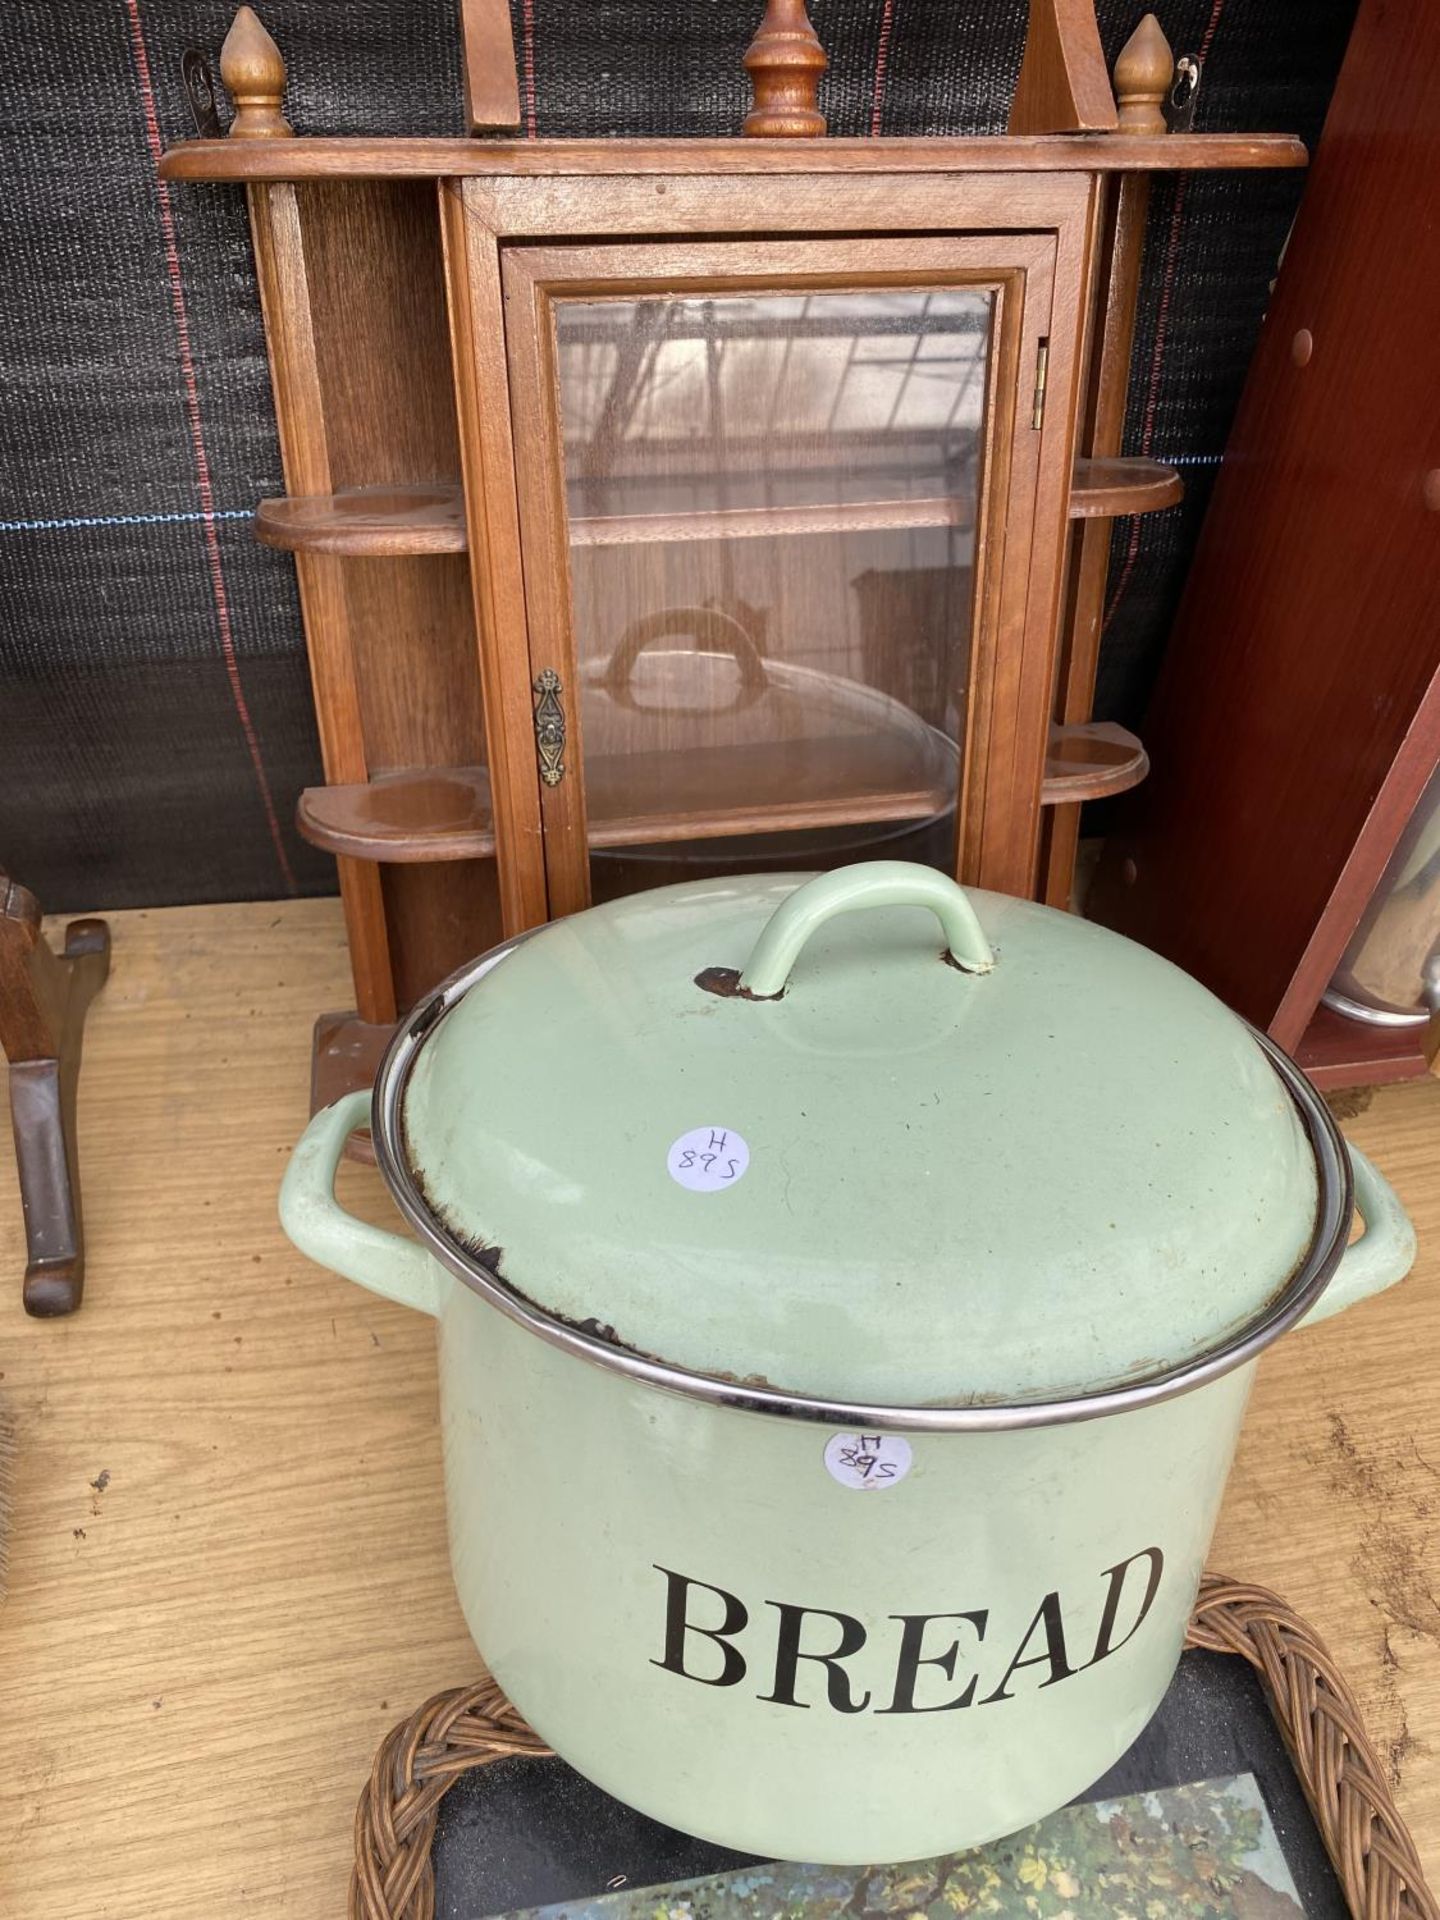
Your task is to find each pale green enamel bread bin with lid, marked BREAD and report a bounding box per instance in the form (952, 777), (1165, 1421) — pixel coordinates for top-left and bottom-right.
(282, 862), (1413, 1864)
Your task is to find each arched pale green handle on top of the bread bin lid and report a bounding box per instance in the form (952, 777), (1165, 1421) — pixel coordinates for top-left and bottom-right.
(739, 860), (995, 1000)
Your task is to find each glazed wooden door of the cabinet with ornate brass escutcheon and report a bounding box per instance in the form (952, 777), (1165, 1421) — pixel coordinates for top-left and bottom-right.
(501, 232), (1064, 914)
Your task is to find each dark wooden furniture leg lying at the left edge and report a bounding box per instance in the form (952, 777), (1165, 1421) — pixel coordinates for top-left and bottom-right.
(0, 874), (109, 1317)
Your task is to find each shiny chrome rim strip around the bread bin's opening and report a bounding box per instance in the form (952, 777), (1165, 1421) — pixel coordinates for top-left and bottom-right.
(371, 929), (1354, 1434)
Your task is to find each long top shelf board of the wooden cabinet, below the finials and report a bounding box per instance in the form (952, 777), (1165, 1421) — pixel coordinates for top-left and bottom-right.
(159, 132), (1306, 180)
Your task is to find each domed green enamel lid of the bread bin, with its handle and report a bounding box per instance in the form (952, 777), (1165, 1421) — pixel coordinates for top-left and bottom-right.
(391, 862), (1342, 1407)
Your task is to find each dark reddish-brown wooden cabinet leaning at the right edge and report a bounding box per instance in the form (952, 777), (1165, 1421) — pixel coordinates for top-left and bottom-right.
(1092, 0), (1440, 1085)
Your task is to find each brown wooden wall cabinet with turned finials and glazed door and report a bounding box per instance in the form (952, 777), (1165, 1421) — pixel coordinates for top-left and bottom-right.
(163, 0), (1304, 1121)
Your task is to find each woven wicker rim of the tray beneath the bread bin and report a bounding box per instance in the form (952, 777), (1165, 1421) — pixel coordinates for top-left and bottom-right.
(349, 1574), (1440, 1920)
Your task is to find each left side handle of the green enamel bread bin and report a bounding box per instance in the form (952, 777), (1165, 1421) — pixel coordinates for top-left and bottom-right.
(280, 1089), (444, 1315)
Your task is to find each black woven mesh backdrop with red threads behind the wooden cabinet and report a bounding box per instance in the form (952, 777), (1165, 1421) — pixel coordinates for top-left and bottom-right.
(0, 0), (1354, 910)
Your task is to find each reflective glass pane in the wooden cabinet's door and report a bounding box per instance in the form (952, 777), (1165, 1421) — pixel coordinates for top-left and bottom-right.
(555, 288), (993, 899)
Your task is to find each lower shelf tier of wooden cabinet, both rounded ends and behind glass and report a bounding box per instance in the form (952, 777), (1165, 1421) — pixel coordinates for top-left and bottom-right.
(296, 724), (1150, 864)
